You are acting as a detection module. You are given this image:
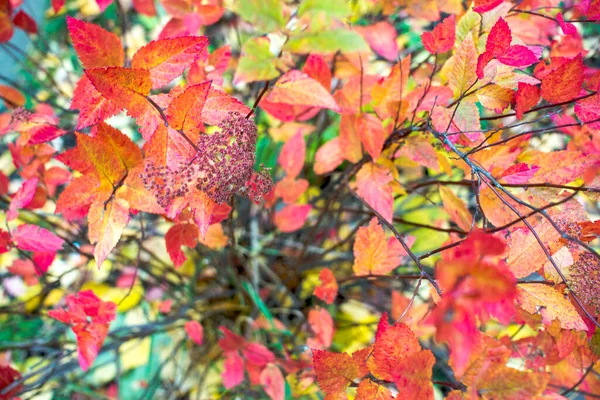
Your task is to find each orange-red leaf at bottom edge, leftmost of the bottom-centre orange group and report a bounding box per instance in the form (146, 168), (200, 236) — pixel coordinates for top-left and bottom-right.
(313, 350), (358, 399)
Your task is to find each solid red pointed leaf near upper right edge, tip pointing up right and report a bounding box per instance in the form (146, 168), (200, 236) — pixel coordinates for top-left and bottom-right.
(542, 53), (584, 103)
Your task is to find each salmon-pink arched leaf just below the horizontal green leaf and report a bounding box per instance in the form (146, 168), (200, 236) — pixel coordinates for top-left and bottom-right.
(267, 70), (341, 112)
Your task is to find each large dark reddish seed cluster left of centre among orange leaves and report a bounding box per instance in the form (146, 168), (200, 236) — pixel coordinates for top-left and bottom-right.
(142, 112), (273, 208)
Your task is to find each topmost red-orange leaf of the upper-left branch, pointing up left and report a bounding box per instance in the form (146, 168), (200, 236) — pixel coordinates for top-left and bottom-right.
(67, 16), (125, 68)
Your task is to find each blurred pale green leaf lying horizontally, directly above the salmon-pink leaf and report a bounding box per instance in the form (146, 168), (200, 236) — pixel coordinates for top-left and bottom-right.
(285, 28), (369, 54)
